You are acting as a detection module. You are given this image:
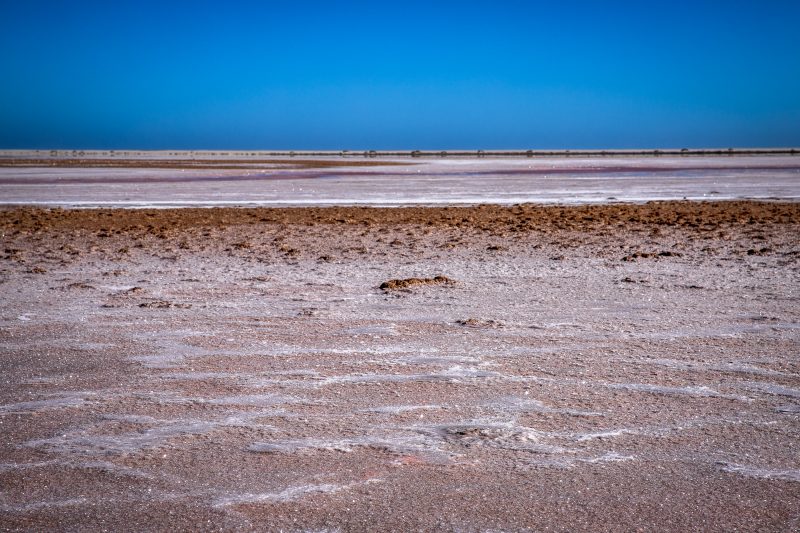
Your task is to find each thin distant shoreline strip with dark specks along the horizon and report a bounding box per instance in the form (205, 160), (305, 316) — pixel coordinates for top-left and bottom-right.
(0, 148), (800, 160)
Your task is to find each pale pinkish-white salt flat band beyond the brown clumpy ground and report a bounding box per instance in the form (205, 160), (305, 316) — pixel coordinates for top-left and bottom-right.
(0, 156), (800, 208)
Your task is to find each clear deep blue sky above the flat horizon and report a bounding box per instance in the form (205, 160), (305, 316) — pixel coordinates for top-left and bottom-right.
(0, 0), (800, 150)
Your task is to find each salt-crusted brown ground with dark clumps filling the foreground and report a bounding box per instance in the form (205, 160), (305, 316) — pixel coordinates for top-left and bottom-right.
(0, 202), (800, 531)
